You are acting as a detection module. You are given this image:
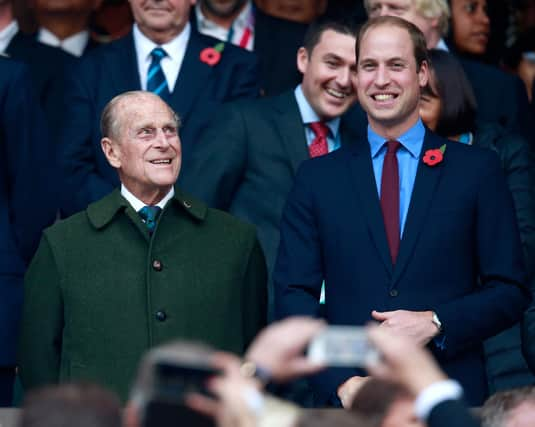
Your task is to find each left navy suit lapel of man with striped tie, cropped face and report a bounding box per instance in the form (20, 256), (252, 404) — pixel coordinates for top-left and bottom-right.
(107, 32), (141, 93)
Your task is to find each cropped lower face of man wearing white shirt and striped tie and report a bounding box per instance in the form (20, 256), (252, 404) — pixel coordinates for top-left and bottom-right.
(129, 0), (195, 44)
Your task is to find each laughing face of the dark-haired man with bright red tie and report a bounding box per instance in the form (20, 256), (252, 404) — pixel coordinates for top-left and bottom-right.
(297, 30), (356, 120)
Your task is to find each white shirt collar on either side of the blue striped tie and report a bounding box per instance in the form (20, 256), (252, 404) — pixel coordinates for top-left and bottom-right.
(132, 22), (191, 92)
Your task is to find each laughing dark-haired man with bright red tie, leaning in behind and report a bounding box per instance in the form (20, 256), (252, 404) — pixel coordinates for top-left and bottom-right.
(180, 16), (365, 320)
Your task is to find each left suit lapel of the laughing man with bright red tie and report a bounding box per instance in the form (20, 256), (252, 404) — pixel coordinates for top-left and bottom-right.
(273, 91), (309, 174)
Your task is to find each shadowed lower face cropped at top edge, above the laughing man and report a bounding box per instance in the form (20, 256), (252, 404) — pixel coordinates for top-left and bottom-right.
(256, 0), (327, 23)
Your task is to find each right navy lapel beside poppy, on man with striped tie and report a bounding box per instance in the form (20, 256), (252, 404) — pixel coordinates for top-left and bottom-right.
(170, 31), (214, 122)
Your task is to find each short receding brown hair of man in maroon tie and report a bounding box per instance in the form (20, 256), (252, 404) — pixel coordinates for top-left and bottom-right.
(355, 16), (429, 70)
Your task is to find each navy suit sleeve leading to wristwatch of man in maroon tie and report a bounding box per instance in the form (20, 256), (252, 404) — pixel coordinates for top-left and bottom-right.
(436, 152), (529, 355)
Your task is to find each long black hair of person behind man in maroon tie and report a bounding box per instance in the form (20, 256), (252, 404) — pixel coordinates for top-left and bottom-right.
(429, 49), (477, 137)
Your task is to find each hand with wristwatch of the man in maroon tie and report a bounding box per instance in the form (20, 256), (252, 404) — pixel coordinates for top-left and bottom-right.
(372, 310), (440, 346)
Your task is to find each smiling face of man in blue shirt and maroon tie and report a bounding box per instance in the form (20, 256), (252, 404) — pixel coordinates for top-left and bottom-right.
(357, 25), (428, 135)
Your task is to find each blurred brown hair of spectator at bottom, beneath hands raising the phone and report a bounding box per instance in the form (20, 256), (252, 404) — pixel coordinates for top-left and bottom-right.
(351, 378), (414, 425)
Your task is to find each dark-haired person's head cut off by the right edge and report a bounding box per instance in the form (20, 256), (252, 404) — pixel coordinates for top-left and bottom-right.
(504, 27), (535, 103)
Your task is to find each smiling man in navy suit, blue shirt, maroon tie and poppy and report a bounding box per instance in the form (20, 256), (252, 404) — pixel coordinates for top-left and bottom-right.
(273, 17), (529, 406)
